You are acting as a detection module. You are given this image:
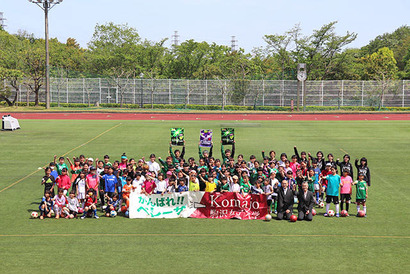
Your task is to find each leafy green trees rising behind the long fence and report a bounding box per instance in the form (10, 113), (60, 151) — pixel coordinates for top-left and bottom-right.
(0, 21), (410, 105)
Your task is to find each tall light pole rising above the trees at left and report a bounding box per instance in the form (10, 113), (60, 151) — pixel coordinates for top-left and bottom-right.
(28, 0), (63, 109)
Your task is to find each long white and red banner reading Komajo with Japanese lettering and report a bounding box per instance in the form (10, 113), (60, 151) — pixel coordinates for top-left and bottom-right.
(129, 192), (268, 220)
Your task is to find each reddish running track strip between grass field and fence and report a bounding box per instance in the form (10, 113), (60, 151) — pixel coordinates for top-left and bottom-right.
(0, 112), (410, 121)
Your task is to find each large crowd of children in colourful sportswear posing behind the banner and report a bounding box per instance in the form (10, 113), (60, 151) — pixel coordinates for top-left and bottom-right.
(39, 143), (370, 219)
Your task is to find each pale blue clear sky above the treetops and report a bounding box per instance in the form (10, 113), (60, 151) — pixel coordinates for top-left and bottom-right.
(0, 0), (410, 52)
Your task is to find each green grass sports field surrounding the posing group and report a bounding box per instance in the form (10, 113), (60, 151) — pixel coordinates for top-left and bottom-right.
(0, 120), (410, 273)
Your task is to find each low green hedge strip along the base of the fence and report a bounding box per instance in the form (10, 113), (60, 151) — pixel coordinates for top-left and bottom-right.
(0, 101), (410, 112)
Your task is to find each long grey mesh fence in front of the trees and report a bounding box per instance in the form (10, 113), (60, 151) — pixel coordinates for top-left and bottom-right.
(6, 78), (410, 107)
